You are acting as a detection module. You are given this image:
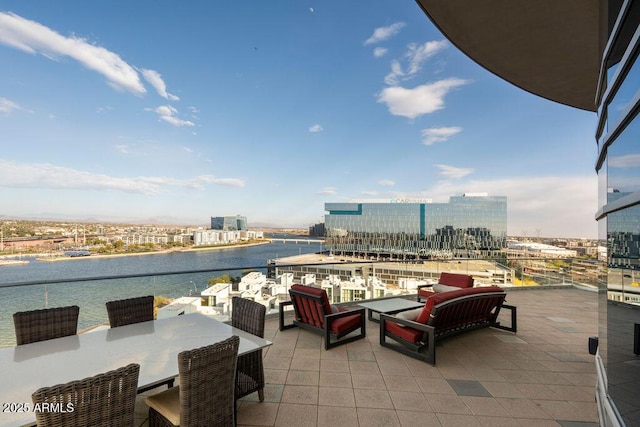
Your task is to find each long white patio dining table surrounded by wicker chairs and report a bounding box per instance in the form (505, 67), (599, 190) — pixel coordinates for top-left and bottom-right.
(0, 313), (272, 426)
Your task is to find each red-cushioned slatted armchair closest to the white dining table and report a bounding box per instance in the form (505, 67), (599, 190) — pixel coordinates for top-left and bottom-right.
(280, 285), (367, 350)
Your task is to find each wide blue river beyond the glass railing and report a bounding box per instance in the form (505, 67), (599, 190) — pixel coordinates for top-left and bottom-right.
(0, 242), (322, 346)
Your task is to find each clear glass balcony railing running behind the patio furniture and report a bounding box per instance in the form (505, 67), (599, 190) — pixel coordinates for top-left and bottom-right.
(0, 257), (604, 346)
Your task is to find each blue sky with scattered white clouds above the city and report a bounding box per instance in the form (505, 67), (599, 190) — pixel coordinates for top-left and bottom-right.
(0, 0), (597, 238)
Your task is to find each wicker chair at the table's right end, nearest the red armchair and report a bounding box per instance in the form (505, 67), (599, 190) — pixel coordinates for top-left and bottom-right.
(231, 297), (266, 402)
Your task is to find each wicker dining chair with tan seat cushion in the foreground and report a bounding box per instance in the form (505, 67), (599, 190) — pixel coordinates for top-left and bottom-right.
(146, 335), (240, 427)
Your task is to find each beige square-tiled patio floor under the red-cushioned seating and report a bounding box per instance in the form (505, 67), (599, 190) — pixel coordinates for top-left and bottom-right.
(136, 288), (598, 427)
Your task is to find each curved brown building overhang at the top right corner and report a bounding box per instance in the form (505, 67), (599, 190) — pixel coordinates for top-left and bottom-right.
(416, 0), (606, 111)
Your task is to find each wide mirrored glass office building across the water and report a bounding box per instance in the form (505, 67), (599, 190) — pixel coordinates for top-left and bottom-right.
(325, 195), (507, 259)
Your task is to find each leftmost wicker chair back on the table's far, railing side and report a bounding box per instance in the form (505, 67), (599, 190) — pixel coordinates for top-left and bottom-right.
(13, 305), (80, 345)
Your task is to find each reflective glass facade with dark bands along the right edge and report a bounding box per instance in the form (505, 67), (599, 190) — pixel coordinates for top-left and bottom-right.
(596, 1), (640, 426)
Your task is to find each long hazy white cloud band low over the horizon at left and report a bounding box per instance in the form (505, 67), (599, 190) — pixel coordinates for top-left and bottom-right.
(0, 160), (244, 195)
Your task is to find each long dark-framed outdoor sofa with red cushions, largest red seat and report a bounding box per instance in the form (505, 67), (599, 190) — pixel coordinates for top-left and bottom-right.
(380, 286), (517, 365)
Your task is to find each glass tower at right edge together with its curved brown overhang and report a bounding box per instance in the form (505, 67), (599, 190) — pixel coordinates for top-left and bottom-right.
(416, 0), (640, 426)
